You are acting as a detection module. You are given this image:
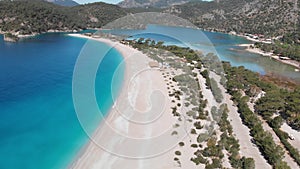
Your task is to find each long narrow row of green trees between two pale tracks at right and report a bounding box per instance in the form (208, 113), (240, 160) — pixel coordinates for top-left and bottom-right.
(227, 63), (289, 168)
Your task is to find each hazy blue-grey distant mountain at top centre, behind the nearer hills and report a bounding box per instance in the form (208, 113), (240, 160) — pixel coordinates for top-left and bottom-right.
(118, 0), (191, 8)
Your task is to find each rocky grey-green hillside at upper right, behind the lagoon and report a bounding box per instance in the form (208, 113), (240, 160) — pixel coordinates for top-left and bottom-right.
(165, 0), (300, 36)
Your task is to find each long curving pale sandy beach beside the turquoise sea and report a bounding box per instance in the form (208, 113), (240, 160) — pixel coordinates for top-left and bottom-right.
(70, 34), (189, 169)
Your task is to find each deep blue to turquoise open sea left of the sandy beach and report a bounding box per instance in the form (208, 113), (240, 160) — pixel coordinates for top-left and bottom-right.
(0, 34), (122, 169)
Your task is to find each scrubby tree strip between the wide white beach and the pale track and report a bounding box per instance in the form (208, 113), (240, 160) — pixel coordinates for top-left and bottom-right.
(129, 39), (255, 169)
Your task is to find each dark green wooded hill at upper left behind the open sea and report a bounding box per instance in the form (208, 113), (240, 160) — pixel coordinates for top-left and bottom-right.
(0, 0), (126, 34)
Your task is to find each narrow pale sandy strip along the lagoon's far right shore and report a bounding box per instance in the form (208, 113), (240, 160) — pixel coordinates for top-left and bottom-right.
(238, 44), (300, 70)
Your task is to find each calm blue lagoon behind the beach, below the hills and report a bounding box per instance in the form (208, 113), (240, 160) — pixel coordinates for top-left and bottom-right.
(111, 25), (300, 82)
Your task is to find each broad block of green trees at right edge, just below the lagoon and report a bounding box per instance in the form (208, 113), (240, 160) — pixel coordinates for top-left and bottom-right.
(223, 63), (300, 130)
